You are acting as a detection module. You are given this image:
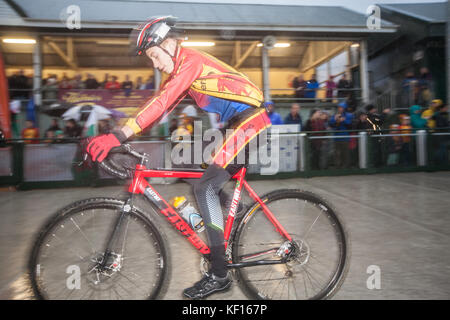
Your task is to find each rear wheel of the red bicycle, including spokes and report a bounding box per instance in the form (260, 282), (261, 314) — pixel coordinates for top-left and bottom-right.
(232, 190), (348, 300)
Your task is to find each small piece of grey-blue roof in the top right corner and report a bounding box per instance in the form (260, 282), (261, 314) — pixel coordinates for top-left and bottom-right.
(378, 2), (448, 23)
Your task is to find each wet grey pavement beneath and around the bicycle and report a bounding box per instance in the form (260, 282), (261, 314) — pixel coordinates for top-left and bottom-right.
(0, 172), (450, 300)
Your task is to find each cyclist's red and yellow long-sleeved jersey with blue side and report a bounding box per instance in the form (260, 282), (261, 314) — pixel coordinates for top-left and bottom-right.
(126, 47), (264, 133)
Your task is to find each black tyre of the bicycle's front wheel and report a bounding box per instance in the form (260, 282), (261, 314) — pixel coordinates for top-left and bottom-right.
(28, 198), (171, 299)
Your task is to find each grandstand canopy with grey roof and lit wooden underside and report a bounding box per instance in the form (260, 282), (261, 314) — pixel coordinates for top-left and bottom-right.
(0, 0), (397, 77)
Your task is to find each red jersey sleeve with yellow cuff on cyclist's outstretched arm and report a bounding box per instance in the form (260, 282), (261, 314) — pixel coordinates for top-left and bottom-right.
(126, 56), (203, 134)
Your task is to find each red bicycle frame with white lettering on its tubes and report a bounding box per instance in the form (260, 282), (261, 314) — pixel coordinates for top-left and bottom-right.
(128, 164), (292, 262)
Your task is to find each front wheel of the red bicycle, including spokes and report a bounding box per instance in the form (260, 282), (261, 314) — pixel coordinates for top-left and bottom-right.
(29, 198), (170, 300)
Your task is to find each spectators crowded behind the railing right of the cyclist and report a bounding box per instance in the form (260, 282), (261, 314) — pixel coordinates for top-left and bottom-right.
(266, 99), (450, 169)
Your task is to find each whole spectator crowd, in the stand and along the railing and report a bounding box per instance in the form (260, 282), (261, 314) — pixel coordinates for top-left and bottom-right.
(4, 68), (450, 169)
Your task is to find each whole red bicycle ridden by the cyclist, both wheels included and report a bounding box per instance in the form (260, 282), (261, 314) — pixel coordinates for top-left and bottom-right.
(28, 144), (348, 299)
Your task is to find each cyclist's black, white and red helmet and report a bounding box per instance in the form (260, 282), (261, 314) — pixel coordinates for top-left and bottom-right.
(131, 16), (180, 56)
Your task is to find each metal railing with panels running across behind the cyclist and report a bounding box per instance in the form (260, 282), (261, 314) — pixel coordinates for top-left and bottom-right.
(0, 126), (450, 188)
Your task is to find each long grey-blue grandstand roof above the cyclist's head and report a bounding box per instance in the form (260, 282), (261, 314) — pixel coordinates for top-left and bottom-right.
(3, 0), (395, 32)
